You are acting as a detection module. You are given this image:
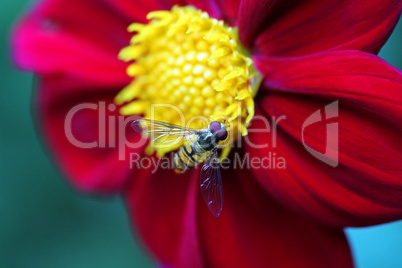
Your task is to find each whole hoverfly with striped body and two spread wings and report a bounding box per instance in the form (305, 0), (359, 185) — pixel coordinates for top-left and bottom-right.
(131, 119), (229, 217)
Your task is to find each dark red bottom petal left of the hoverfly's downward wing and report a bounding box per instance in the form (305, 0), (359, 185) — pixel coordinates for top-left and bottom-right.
(126, 166), (202, 267)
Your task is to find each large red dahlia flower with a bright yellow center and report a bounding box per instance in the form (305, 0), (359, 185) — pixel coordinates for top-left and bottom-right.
(12, 0), (402, 268)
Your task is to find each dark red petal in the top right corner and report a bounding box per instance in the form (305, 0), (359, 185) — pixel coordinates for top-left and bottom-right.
(239, 0), (402, 57)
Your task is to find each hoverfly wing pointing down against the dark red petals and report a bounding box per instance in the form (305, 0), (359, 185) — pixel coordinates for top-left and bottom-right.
(200, 150), (223, 217)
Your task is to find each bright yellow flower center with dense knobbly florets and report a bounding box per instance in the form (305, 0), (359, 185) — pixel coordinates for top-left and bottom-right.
(115, 6), (261, 155)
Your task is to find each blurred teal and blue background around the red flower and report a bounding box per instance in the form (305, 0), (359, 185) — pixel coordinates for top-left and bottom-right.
(0, 0), (402, 268)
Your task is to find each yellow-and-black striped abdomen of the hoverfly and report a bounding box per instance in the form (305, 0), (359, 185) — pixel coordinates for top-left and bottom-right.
(173, 142), (206, 172)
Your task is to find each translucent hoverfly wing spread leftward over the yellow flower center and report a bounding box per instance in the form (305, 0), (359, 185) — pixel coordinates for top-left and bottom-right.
(131, 119), (198, 146)
